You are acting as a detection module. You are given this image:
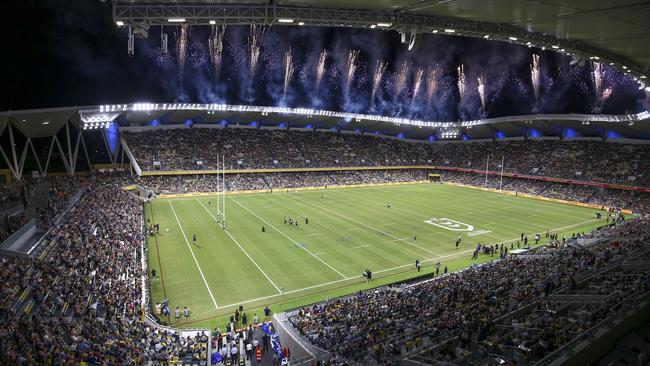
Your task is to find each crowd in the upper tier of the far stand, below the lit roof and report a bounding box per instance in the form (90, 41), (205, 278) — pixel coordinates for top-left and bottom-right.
(124, 128), (650, 186)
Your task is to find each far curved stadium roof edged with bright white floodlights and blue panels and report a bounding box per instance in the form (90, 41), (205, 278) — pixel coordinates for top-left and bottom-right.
(0, 103), (650, 140)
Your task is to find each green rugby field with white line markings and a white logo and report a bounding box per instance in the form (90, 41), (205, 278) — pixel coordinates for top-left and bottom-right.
(145, 183), (605, 327)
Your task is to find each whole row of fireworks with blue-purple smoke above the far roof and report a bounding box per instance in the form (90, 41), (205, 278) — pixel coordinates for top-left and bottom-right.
(138, 24), (645, 120)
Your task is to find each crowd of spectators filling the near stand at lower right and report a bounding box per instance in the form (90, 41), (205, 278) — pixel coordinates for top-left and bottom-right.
(292, 216), (650, 364)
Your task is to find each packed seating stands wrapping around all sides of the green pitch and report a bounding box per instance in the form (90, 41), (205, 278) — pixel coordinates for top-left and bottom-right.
(0, 129), (650, 365)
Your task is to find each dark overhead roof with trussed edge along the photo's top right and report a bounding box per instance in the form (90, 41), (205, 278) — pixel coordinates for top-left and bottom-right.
(113, 0), (650, 78)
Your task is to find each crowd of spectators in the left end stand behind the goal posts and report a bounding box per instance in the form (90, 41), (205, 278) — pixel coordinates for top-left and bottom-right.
(0, 176), (207, 365)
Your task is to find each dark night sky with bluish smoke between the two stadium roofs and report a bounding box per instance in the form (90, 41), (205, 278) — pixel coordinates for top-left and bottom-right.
(0, 0), (645, 121)
